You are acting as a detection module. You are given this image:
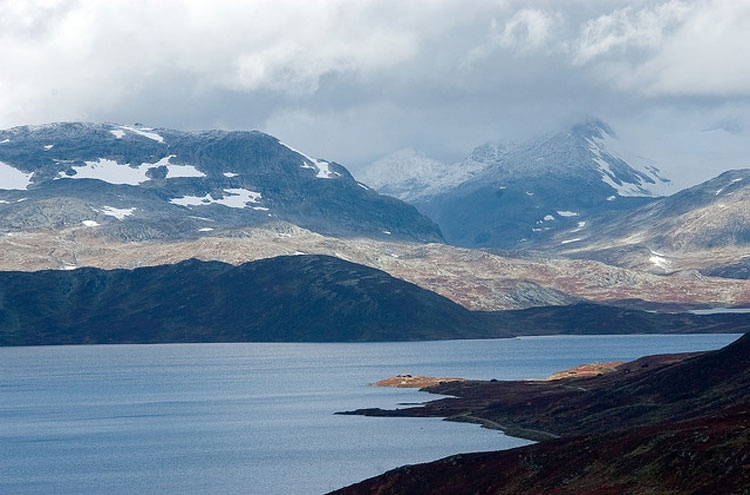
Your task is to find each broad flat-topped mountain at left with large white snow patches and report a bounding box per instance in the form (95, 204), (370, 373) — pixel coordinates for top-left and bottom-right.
(0, 123), (442, 242)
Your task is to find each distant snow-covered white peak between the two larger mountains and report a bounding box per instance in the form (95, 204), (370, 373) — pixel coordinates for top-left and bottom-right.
(359, 148), (486, 202)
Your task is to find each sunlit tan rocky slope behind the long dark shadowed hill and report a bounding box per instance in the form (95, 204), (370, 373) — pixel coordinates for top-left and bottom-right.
(0, 223), (750, 311)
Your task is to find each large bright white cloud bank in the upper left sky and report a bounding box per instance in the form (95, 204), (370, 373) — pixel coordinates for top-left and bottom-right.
(0, 0), (426, 123)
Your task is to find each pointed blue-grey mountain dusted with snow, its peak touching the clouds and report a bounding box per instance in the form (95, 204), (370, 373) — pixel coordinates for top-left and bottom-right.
(370, 120), (671, 249)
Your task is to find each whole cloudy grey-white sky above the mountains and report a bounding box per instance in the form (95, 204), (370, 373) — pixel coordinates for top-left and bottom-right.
(0, 0), (750, 190)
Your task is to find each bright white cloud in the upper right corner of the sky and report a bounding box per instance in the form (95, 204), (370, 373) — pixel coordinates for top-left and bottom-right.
(575, 0), (750, 98)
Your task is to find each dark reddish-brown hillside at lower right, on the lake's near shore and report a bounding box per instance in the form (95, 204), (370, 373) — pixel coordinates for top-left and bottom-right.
(334, 335), (750, 495)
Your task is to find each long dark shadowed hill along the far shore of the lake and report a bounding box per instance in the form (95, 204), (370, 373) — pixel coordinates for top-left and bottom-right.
(0, 256), (750, 345)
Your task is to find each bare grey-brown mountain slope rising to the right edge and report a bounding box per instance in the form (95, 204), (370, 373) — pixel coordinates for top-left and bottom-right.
(548, 169), (750, 278)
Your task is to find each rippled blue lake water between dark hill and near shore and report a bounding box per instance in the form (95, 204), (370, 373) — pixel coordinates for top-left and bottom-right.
(0, 335), (738, 494)
